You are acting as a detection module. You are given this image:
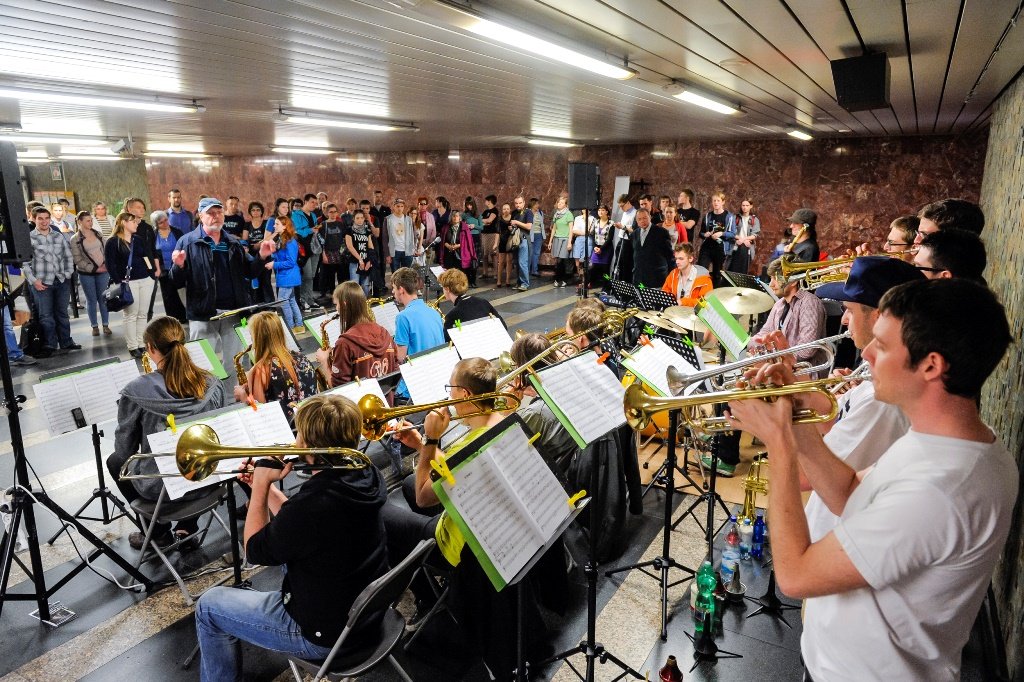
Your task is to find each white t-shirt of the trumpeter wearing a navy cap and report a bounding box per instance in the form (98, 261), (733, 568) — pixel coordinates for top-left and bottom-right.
(804, 381), (910, 543)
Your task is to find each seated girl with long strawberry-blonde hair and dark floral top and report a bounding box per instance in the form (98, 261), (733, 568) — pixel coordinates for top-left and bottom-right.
(234, 311), (317, 423)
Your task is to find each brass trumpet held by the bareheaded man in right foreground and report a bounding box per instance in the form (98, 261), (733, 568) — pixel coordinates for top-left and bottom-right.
(623, 377), (847, 433)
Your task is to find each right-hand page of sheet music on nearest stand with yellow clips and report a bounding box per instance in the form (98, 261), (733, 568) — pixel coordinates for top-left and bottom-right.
(485, 427), (572, 543)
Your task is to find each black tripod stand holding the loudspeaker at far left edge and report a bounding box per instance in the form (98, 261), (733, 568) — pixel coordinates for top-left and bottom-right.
(0, 288), (153, 622)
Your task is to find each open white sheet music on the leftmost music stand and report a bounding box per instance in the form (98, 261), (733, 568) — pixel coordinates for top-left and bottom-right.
(32, 360), (139, 435)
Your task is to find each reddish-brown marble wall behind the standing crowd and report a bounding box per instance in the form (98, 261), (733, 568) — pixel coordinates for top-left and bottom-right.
(147, 132), (985, 268)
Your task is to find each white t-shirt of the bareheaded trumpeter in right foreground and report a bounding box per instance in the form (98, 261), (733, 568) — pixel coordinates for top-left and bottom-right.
(801, 429), (1018, 682)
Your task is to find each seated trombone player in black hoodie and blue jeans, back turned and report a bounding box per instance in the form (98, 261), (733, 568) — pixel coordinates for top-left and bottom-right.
(196, 395), (388, 682)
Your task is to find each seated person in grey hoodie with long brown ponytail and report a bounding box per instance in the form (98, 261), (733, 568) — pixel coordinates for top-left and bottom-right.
(106, 316), (224, 549)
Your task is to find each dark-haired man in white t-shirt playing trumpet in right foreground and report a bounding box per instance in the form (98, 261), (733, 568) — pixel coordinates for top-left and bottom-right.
(729, 280), (1018, 680)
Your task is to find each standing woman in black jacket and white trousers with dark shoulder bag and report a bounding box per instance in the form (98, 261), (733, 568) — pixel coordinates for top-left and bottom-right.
(103, 213), (157, 358)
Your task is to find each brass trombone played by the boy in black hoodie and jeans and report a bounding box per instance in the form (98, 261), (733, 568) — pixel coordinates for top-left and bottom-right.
(119, 424), (372, 481)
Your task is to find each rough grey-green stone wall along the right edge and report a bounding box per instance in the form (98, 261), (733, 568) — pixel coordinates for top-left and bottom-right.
(981, 69), (1024, 680)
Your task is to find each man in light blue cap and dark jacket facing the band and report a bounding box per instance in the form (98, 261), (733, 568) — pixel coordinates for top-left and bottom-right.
(171, 197), (273, 365)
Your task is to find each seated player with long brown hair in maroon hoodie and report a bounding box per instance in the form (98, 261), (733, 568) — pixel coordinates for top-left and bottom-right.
(316, 282), (398, 388)
